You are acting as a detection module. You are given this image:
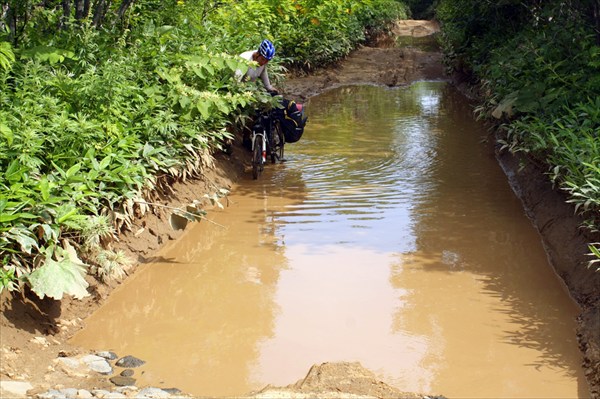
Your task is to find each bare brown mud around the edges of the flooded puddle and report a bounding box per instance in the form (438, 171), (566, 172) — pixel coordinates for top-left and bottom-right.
(0, 21), (600, 399)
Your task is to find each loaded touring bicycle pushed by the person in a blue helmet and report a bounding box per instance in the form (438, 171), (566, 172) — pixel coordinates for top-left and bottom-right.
(251, 109), (285, 180)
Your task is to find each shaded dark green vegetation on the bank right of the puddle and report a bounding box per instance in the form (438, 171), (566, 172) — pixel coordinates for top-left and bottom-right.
(436, 0), (600, 265)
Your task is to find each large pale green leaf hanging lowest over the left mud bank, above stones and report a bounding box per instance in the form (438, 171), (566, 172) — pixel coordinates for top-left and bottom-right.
(28, 246), (89, 300)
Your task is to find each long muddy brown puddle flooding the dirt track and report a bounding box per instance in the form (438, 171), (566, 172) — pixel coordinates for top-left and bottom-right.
(72, 82), (589, 398)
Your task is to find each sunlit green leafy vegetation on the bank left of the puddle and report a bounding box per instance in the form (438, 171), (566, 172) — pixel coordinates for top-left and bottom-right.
(0, 0), (406, 298)
